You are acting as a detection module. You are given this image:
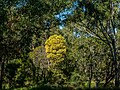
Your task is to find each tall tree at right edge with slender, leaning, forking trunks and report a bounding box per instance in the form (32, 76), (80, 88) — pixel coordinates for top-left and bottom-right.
(68, 0), (119, 87)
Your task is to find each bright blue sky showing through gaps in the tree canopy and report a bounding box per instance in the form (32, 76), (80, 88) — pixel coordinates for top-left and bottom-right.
(16, 0), (120, 36)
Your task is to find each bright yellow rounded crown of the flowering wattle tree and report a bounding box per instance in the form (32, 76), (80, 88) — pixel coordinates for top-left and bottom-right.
(45, 34), (66, 66)
